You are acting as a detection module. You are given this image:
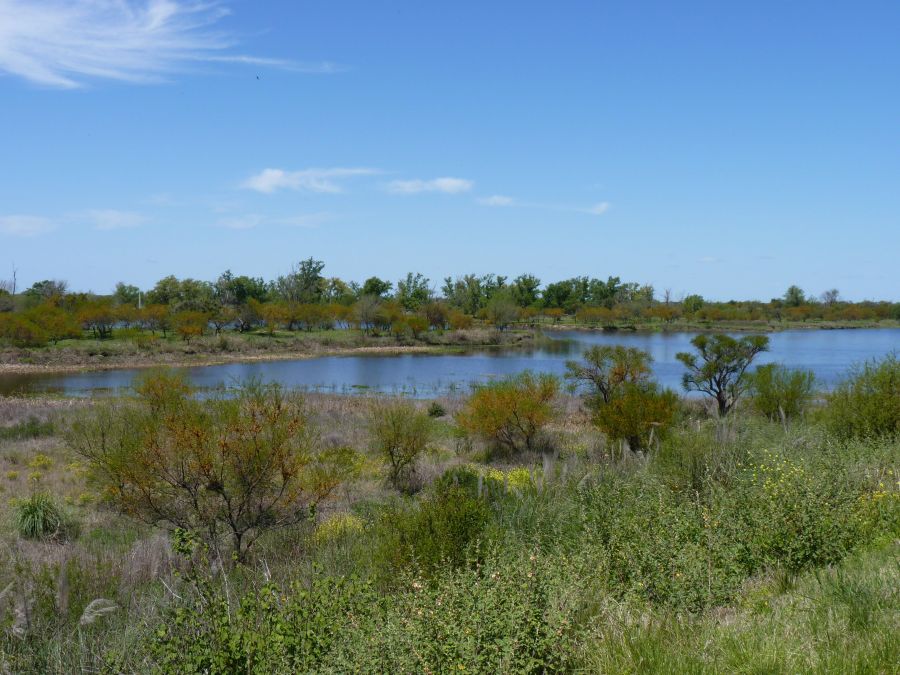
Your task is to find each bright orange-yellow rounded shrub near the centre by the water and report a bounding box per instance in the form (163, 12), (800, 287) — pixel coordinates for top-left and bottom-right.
(456, 371), (559, 452)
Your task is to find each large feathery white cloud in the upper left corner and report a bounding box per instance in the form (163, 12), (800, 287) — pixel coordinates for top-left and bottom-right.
(0, 0), (341, 89)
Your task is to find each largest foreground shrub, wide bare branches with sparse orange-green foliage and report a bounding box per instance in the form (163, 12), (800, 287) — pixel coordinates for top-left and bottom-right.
(67, 371), (356, 561)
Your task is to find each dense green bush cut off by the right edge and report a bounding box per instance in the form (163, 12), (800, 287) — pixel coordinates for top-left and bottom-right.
(825, 354), (900, 438)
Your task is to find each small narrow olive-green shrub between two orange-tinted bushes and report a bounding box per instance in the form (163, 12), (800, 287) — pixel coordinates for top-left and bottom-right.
(369, 399), (433, 492)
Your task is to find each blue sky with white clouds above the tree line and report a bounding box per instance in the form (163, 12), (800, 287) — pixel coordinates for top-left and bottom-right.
(0, 0), (900, 300)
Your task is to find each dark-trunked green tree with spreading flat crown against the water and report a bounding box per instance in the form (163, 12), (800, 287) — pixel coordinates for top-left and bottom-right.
(675, 334), (769, 417)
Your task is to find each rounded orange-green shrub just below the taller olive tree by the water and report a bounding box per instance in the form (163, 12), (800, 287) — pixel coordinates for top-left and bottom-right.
(594, 382), (678, 451)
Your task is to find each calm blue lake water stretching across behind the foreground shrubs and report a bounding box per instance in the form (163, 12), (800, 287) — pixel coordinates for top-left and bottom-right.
(0, 328), (900, 397)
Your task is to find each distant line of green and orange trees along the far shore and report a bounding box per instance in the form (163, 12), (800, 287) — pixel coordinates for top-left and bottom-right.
(0, 258), (900, 346)
